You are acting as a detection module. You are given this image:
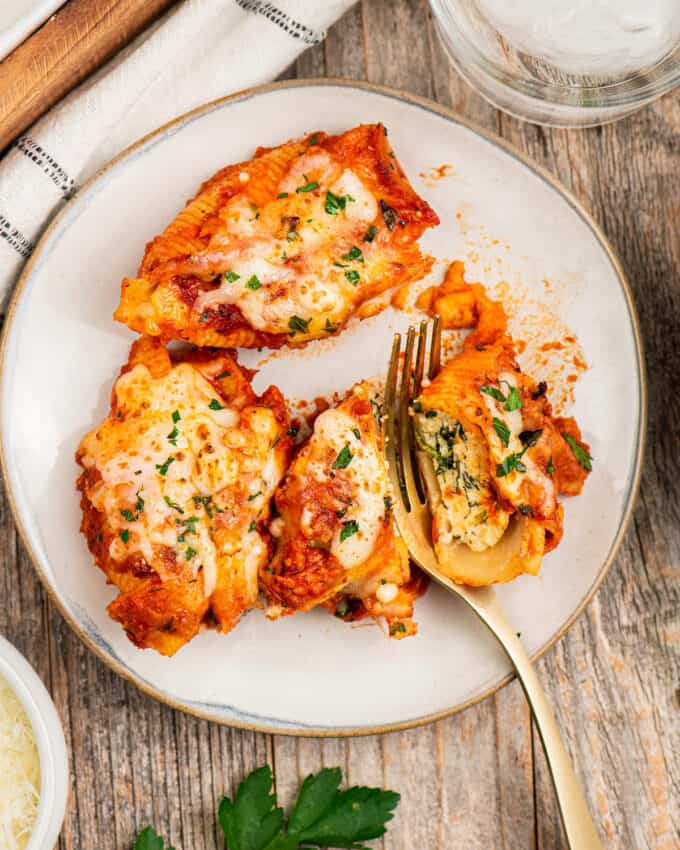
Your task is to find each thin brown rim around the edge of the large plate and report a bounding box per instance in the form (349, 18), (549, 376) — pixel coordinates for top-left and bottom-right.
(0, 77), (648, 738)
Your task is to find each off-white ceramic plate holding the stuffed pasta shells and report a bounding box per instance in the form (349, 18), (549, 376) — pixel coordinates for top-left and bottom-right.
(1, 81), (645, 734)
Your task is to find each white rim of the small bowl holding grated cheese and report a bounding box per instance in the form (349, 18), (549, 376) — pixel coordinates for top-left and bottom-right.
(0, 636), (69, 850)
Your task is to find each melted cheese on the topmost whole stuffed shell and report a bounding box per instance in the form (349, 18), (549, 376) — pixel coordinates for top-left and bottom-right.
(194, 166), (378, 333)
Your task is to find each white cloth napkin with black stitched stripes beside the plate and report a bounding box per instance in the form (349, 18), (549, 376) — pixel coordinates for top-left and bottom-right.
(0, 0), (354, 307)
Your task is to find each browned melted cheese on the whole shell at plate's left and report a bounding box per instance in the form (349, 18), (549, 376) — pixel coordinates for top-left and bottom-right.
(82, 363), (283, 596)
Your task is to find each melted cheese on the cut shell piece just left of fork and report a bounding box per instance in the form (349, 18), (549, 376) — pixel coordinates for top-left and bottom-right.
(310, 409), (389, 570)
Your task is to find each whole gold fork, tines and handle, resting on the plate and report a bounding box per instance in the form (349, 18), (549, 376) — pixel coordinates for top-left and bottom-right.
(385, 317), (602, 850)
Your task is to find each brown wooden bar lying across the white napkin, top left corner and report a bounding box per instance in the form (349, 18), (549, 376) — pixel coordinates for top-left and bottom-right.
(0, 0), (177, 151)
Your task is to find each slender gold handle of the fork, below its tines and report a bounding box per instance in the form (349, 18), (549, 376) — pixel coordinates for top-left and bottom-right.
(464, 588), (602, 850)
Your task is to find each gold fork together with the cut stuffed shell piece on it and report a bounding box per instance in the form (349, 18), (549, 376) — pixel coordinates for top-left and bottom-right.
(384, 268), (602, 850)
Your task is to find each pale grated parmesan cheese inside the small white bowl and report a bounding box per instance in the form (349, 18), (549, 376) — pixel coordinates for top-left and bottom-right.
(0, 678), (40, 850)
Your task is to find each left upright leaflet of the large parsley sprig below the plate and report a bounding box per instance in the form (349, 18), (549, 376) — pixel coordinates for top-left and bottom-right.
(216, 767), (282, 850)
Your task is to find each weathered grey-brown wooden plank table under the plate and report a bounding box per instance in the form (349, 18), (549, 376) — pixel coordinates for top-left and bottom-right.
(0, 0), (680, 850)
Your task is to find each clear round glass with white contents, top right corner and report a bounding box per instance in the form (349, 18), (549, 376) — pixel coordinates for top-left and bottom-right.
(430, 0), (680, 127)
